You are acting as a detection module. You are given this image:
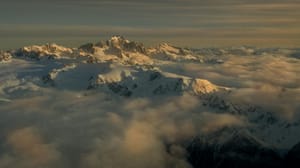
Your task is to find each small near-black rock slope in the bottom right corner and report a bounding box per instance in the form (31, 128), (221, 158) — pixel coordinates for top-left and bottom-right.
(285, 142), (300, 168)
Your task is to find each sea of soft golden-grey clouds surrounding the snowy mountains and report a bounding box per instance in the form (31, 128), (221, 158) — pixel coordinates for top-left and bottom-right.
(0, 49), (300, 168)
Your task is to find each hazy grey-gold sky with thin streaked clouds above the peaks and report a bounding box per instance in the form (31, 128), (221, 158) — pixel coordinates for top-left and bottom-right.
(0, 0), (300, 49)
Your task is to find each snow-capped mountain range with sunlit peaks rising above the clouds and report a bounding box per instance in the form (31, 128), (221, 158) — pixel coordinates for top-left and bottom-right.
(0, 36), (300, 168)
